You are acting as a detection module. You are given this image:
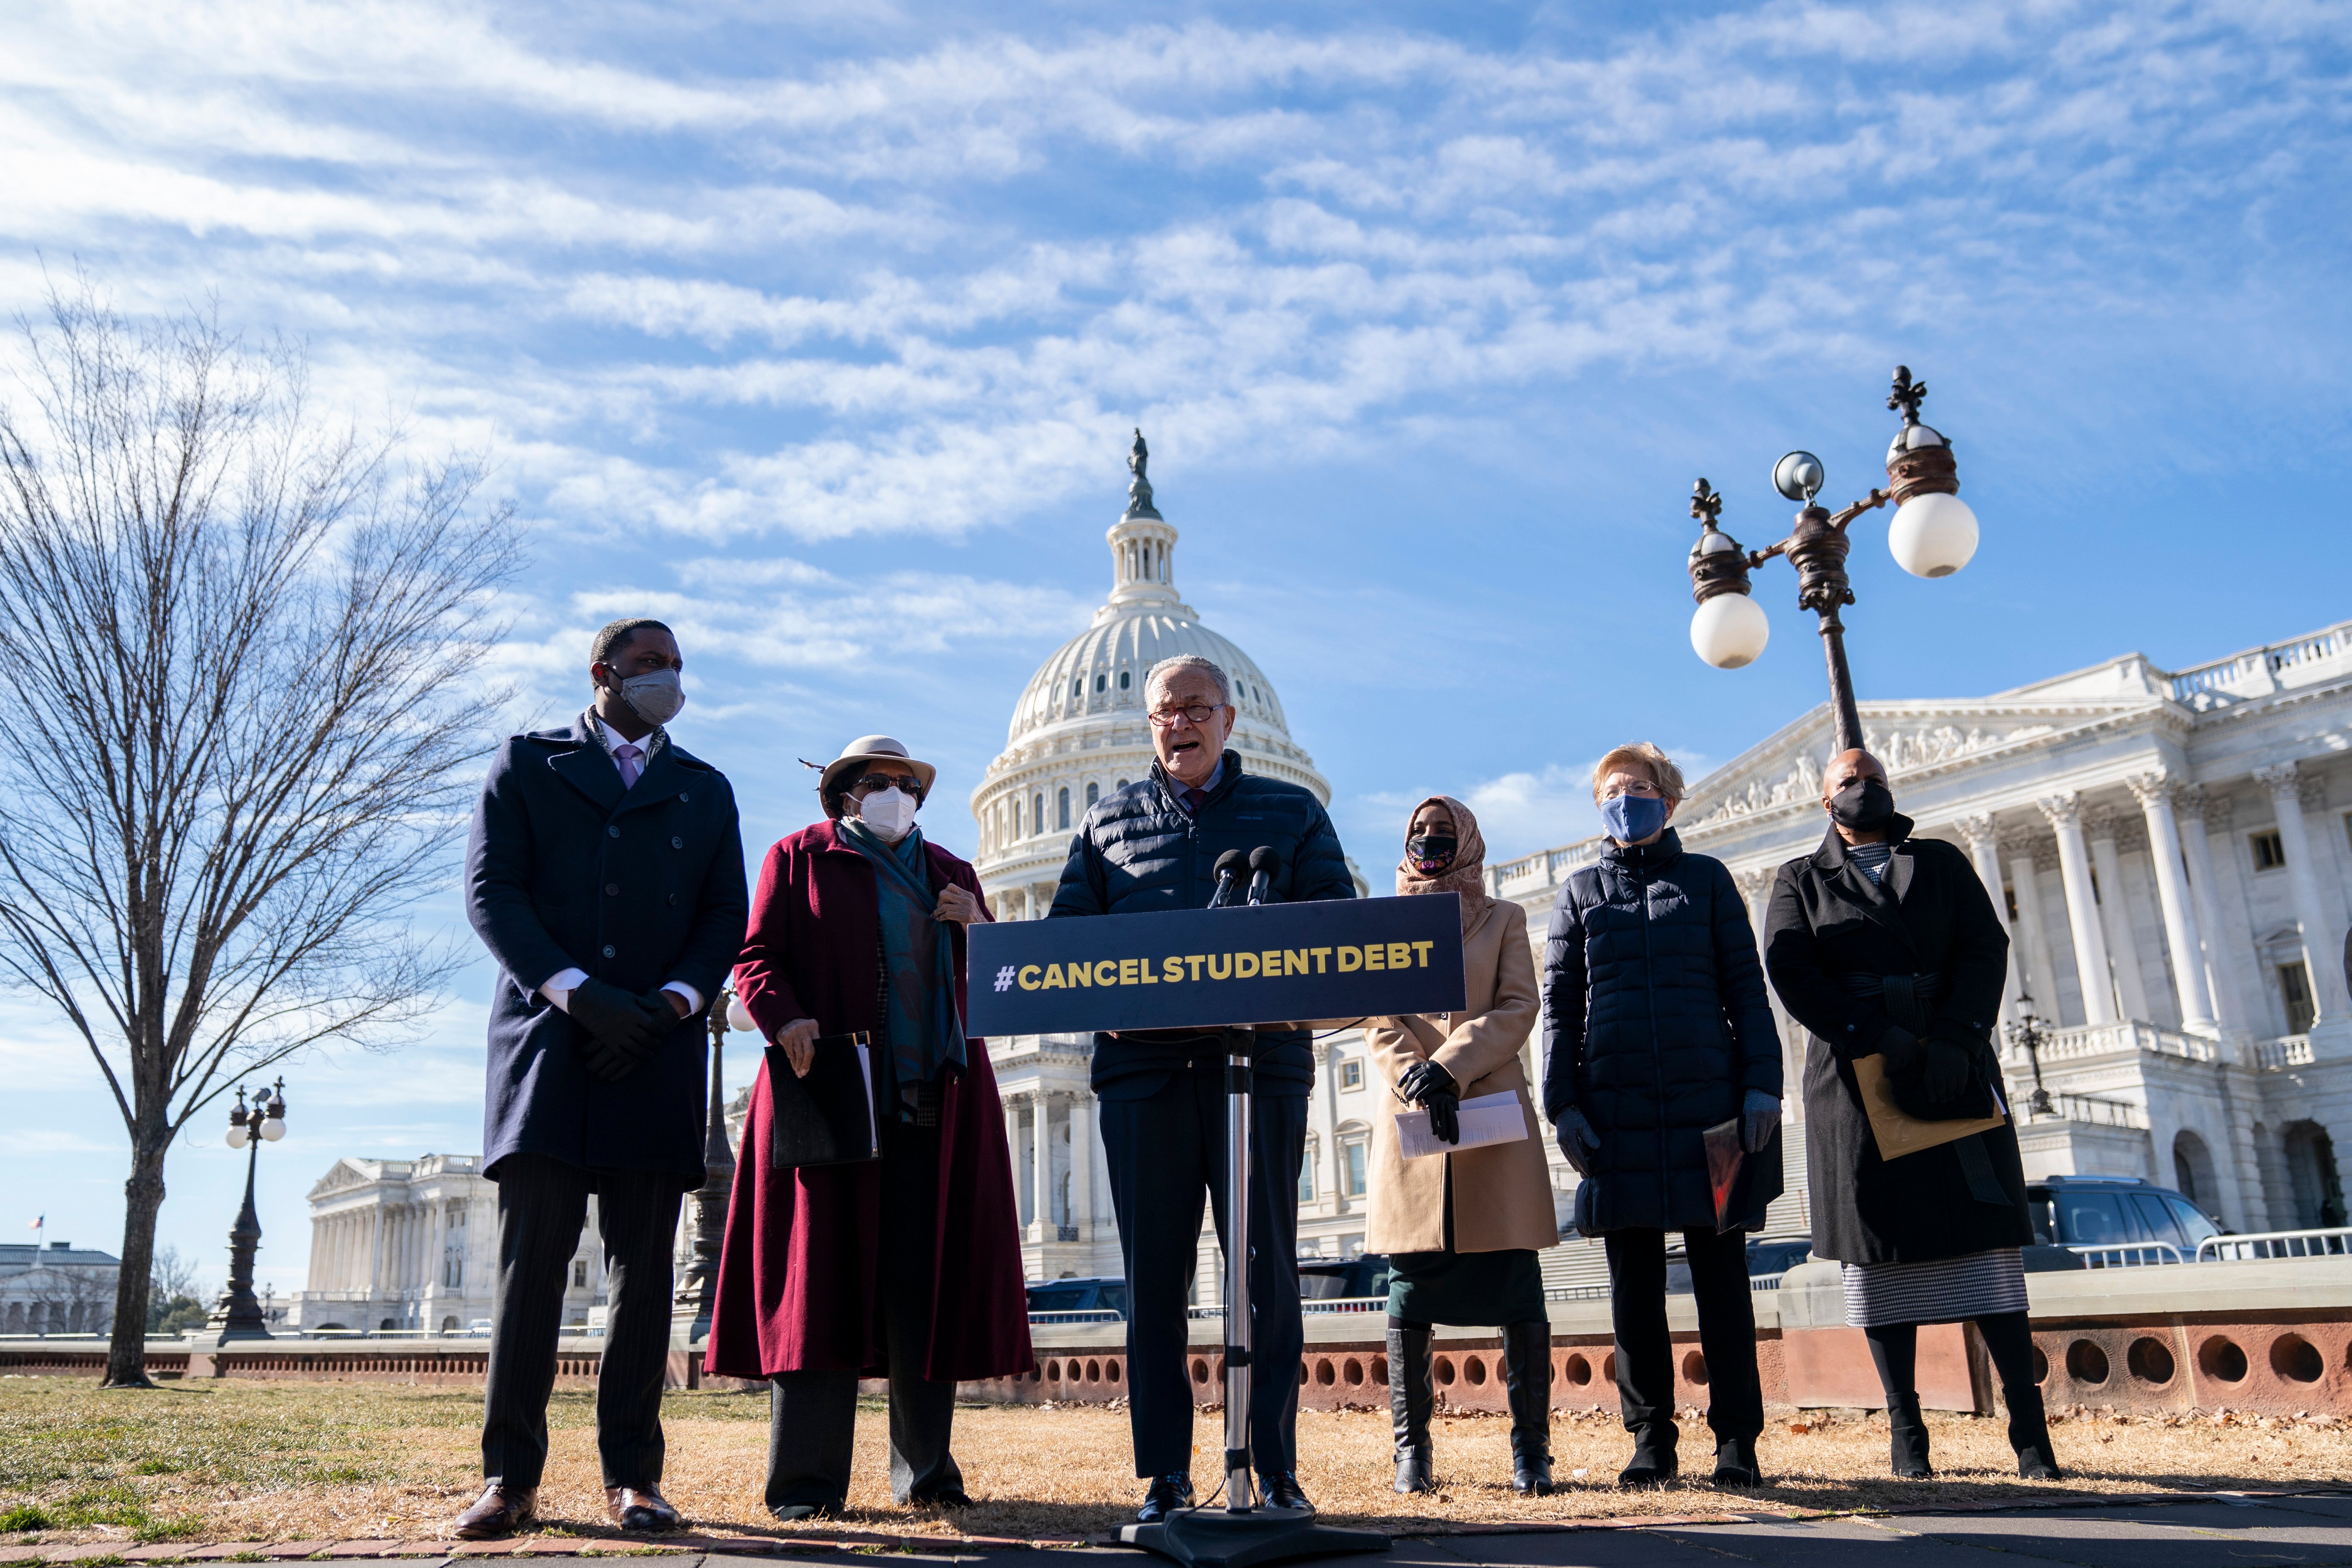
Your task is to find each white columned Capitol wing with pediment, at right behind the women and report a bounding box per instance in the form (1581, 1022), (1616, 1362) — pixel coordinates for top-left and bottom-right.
(1496, 623), (2352, 1241)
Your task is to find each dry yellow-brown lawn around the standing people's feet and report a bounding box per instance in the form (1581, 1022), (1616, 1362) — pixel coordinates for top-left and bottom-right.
(0, 1378), (2352, 1540)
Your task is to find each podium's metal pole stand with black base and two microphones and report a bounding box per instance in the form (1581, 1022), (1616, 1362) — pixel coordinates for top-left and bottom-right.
(1120, 851), (1388, 1568)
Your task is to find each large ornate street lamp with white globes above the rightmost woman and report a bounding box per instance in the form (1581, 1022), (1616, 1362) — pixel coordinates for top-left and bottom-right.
(1689, 364), (1976, 752)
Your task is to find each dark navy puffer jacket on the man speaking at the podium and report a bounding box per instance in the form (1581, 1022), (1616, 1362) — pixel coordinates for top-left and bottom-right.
(1047, 750), (1355, 1098)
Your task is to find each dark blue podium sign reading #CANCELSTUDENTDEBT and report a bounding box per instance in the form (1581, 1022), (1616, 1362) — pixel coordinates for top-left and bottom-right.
(964, 893), (1468, 1037)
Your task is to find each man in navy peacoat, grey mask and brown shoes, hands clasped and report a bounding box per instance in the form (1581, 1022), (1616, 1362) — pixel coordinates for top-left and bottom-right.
(456, 621), (750, 1540)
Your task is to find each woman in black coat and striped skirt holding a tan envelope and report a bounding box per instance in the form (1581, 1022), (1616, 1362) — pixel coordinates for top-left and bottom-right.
(1764, 750), (2058, 1481)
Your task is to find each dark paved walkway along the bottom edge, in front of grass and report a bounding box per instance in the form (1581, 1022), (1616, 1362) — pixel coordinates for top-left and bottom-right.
(0, 1491), (2352, 1568)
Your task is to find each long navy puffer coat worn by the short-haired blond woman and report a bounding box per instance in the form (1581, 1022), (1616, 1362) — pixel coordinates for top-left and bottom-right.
(1543, 828), (1780, 1230)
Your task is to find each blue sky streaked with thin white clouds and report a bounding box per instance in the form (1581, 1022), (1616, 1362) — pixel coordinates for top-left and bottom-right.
(0, 0), (2352, 1288)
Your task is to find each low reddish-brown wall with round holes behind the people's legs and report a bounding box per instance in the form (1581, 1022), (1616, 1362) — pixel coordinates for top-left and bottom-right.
(0, 1258), (2352, 1415)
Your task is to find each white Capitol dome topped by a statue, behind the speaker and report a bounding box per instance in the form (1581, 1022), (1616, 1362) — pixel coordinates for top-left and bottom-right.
(971, 430), (1331, 919)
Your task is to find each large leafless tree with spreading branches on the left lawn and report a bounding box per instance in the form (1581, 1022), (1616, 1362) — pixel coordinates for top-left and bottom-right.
(0, 278), (520, 1387)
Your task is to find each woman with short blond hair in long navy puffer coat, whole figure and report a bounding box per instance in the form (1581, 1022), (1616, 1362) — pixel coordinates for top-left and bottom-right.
(1543, 740), (1780, 1486)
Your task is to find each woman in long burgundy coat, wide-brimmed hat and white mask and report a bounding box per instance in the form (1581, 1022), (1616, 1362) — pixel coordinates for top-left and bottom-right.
(706, 736), (1035, 1521)
